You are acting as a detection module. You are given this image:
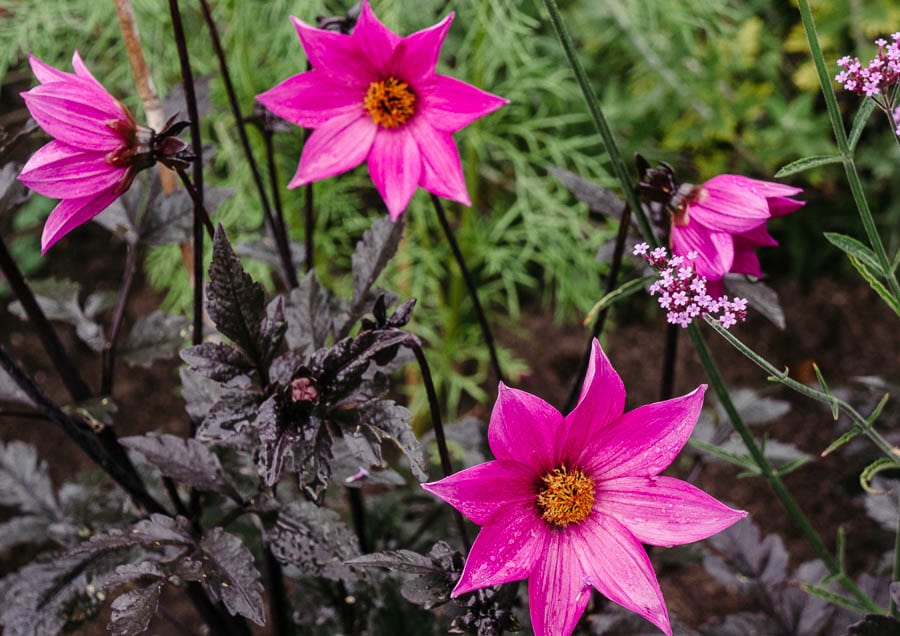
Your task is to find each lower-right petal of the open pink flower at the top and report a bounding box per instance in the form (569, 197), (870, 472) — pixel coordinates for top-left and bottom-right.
(407, 117), (472, 205)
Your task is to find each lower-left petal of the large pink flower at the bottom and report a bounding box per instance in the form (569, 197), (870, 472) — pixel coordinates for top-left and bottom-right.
(451, 504), (551, 597)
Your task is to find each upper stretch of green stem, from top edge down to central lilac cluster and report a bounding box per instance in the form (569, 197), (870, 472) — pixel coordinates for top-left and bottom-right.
(543, 0), (659, 247)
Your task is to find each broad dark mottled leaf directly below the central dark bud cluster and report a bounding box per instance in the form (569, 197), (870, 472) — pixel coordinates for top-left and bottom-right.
(265, 501), (359, 582)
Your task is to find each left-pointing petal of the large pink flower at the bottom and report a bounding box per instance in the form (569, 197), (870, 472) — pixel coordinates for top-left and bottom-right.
(422, 461), (540, 526)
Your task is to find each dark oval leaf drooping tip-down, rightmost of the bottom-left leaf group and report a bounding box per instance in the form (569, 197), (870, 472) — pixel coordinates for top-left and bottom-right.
(200, 528), (266, 626)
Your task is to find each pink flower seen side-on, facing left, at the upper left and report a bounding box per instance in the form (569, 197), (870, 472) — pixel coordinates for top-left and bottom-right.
(19, 51), (154, 253)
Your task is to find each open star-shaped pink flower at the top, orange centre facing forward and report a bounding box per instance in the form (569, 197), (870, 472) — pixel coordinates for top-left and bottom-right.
(256, 2), (507, 220)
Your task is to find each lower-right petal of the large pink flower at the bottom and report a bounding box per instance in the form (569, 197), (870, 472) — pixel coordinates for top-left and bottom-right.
(567, 513), (672, 636)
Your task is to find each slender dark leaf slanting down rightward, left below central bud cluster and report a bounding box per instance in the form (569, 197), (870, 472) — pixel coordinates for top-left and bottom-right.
(119, 433), (239, 498)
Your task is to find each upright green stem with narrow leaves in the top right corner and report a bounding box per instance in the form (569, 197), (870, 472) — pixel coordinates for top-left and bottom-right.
(798, 0), (900, 299)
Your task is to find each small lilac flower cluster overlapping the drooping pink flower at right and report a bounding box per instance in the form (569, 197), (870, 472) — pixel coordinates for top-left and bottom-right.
(634, 243), (747, 329)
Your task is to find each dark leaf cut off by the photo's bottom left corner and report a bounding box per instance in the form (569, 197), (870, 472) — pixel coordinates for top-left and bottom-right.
(0, 555), (100, 636)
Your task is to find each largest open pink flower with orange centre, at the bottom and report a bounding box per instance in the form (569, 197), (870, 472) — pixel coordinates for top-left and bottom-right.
(422, 340), (746, 635)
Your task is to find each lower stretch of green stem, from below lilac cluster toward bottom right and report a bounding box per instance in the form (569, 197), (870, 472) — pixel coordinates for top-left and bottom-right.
(688, 324), (883, 614)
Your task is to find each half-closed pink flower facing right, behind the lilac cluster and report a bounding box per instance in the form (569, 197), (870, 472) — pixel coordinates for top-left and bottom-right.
(671, 174), (805, 286)
